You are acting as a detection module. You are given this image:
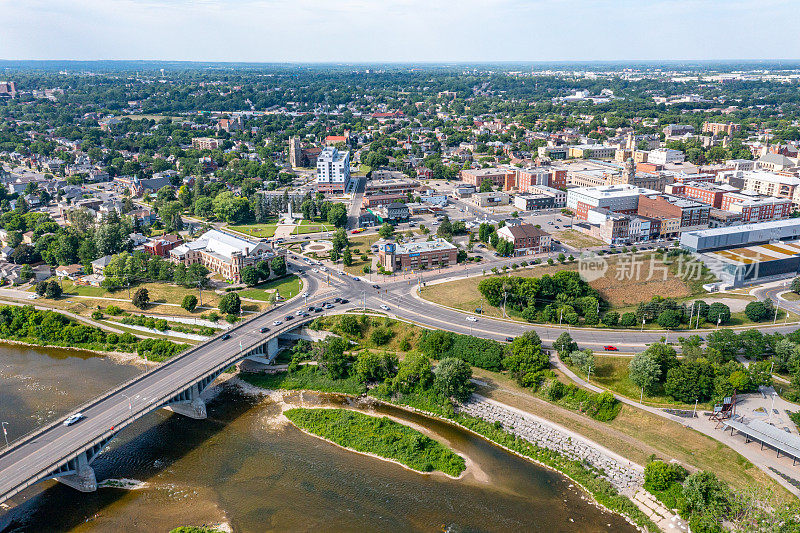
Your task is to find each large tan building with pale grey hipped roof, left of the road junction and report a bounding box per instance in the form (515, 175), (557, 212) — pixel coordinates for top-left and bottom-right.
(169, 229), (276, 283)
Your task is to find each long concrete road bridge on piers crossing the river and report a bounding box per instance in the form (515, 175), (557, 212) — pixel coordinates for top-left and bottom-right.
(0, 298), (316, 503)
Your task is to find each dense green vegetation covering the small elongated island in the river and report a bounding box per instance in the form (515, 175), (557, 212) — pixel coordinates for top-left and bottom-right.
(283, 409), (465, 477)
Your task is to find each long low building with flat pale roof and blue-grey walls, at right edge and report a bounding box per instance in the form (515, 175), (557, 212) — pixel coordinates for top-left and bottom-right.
(681, 218), (800, 253)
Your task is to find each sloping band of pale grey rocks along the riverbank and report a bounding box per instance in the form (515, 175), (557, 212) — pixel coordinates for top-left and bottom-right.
(459, 395), (644, 495)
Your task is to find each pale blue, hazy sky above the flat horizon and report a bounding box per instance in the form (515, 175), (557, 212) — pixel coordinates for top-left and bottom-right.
(0, 0), (800, 62)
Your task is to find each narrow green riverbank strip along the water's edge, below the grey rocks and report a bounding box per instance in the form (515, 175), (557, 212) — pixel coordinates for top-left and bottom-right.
(231, 378), (659, 531)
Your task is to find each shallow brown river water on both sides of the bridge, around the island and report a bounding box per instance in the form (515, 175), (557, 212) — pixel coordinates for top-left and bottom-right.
(0, 346), (634, 533)
